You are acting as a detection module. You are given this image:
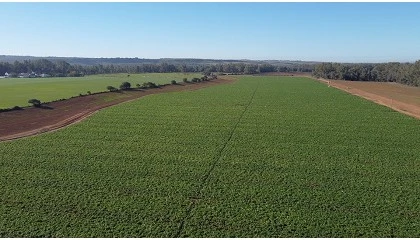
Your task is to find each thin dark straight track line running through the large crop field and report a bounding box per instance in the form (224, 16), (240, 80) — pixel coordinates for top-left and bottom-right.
(174, 82), (260, 238)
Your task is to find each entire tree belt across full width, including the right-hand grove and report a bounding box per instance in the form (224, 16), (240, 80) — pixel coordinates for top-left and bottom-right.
(4, 59), (420, 86)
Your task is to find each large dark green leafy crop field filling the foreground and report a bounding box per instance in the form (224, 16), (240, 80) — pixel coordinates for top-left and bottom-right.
(0, 77), (420, 237)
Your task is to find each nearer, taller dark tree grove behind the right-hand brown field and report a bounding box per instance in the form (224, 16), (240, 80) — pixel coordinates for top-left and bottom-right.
(312, 60), (420, 86)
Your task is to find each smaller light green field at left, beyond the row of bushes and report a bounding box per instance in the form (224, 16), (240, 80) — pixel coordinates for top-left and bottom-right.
(0, 73), (202, 108)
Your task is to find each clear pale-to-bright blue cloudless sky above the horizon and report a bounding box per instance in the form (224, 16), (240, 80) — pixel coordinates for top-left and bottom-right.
(0, 2), (420, 62)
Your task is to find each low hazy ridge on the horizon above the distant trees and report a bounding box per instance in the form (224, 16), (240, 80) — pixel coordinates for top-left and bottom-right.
(0, 55), (320, 67)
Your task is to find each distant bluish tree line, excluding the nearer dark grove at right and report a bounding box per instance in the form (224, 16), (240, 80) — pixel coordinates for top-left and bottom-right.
(0, 59), (314, 77)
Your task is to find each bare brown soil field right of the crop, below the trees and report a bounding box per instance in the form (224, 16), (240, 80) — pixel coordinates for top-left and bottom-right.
(317, 79), (420, 119)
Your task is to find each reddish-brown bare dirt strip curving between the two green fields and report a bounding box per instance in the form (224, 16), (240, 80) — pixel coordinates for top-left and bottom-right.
(0, 77), (234, 142)
